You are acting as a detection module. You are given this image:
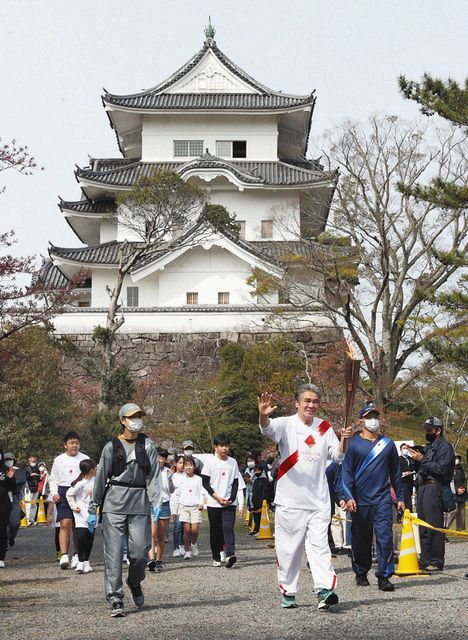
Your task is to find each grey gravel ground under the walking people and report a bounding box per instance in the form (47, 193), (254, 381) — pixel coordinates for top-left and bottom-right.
(0, 523), (468, 640)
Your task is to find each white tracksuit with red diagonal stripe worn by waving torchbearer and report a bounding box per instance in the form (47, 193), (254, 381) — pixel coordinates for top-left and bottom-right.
(260, 414), (344, 596)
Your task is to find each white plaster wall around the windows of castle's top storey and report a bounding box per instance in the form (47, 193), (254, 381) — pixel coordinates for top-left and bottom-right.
(142, 114), (278, 162)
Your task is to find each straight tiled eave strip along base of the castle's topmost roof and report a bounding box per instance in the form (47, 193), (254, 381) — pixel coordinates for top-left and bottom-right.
(104, 93), (315, 111)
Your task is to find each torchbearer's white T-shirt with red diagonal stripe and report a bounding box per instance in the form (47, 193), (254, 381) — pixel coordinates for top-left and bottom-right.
(260, 413), (345, 511)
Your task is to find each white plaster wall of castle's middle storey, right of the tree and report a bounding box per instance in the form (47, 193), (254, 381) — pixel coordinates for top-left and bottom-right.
(210, 190), (299, 240)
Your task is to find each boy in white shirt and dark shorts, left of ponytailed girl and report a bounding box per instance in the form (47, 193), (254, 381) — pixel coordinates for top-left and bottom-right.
(49, 431), (89, 569)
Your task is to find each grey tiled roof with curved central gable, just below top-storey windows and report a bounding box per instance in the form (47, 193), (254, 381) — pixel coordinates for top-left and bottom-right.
(75, 155), (336, 187)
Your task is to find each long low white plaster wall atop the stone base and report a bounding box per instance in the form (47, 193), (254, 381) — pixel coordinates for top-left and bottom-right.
(53, 310), (333, 334)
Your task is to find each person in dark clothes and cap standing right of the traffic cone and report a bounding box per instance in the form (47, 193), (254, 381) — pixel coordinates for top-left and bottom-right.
(408, 416), (455, 571)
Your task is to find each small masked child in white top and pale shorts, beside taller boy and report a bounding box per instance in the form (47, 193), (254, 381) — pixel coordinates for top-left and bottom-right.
(173, 458), (205, 560)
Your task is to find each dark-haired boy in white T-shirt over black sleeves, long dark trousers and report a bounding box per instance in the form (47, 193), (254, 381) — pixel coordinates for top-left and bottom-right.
(202, 433), (244, 569)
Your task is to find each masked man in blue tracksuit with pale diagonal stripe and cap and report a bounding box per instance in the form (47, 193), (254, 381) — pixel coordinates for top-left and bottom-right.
(342, 405), (405, 591)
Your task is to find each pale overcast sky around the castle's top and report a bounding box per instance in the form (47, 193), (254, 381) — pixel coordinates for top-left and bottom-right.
(0, 0), (468, 256)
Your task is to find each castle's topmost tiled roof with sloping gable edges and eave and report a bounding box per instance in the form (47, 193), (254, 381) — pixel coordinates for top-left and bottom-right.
(103, 39), (314, 109)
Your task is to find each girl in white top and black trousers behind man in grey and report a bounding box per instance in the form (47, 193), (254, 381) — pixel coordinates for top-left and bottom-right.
(66, 459), (96, 573)
